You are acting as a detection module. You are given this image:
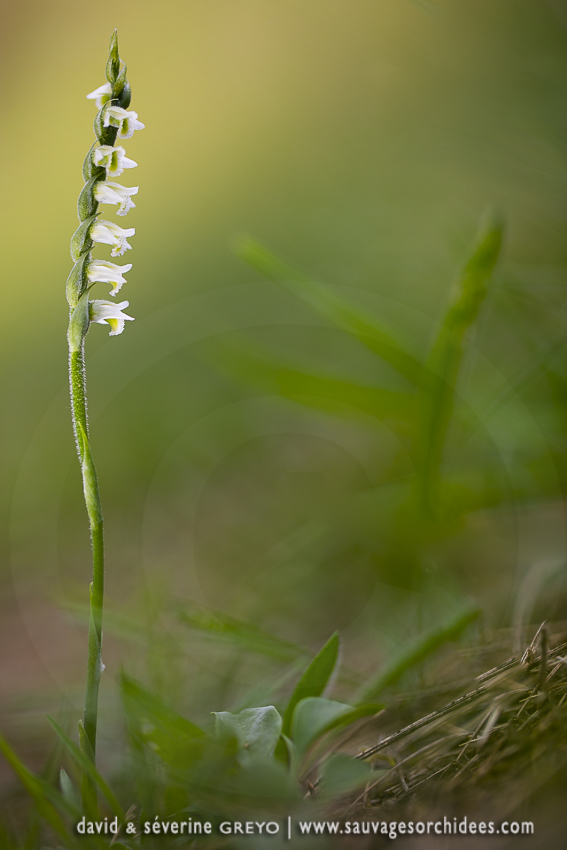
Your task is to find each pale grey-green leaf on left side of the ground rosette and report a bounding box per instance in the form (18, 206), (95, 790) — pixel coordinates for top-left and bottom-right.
(213, 705), (282, 764)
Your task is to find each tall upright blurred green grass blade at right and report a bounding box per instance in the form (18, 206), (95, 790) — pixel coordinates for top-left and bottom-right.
(417, 217), (503, 514)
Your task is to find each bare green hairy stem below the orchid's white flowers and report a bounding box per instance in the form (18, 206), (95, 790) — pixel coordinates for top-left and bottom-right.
(69, 345), (104, 811)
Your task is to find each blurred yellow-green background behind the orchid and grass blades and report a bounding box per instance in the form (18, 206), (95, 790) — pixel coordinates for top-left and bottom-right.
(0, 0), (567, 796)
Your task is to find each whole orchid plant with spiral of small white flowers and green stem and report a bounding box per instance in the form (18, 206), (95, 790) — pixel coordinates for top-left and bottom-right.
(67, 30), (144, 811)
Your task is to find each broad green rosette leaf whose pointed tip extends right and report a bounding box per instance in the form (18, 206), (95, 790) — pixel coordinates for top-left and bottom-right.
(291, 697), (384, 752)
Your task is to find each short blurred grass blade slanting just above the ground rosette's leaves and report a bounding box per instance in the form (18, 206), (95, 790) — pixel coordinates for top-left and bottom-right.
(178, 607), (305, 662)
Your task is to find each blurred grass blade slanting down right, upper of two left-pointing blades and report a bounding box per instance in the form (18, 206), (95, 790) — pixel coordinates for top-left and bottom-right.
(236, 236), (422, 384)
